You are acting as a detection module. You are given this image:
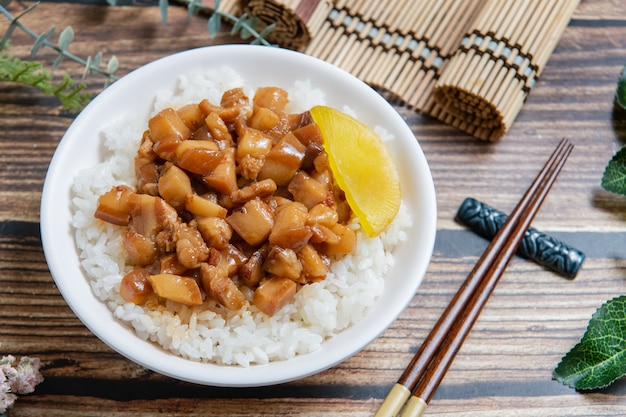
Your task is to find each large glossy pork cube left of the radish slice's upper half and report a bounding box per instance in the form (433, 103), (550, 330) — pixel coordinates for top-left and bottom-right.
(259, 133), (306, 185)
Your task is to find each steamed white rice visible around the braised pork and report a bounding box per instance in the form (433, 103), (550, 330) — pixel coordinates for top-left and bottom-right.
(72, 68), (411, 366)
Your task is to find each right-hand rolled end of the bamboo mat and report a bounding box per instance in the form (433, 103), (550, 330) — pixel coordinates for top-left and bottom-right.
(433, 0), (577, 140)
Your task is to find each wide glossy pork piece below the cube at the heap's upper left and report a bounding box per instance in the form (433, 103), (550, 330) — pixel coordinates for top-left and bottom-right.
(176, 140), (224, 175)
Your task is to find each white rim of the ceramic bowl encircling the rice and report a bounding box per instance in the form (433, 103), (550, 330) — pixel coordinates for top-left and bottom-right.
(40, 45), (437, 387)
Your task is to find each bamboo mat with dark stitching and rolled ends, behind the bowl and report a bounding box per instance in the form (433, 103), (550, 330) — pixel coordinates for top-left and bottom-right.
(220, 0), (580, 140)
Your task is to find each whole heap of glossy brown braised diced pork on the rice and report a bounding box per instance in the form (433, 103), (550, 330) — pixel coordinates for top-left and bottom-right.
(95, 87), (356, 315)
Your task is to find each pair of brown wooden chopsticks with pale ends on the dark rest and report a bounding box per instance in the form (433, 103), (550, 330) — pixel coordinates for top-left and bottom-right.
(375, 139), (573, 417)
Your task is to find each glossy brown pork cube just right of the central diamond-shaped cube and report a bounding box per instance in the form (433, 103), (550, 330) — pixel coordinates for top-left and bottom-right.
(269, 202), (312, 251)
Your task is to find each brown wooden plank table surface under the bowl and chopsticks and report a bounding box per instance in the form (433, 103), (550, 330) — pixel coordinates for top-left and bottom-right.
(0, 0), (626, 417)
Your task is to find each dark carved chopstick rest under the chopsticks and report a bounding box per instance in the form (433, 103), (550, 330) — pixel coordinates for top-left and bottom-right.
(456, 198), (585, 279)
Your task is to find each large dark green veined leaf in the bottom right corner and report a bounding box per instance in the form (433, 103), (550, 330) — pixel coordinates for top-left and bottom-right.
(553, 295), (626, 390)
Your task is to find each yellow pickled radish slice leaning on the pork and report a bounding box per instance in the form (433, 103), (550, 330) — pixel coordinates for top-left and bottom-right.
(311, 106), (402, 237)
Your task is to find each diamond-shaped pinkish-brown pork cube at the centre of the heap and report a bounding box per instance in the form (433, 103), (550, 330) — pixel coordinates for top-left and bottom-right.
(226, 198), (274, 246)
